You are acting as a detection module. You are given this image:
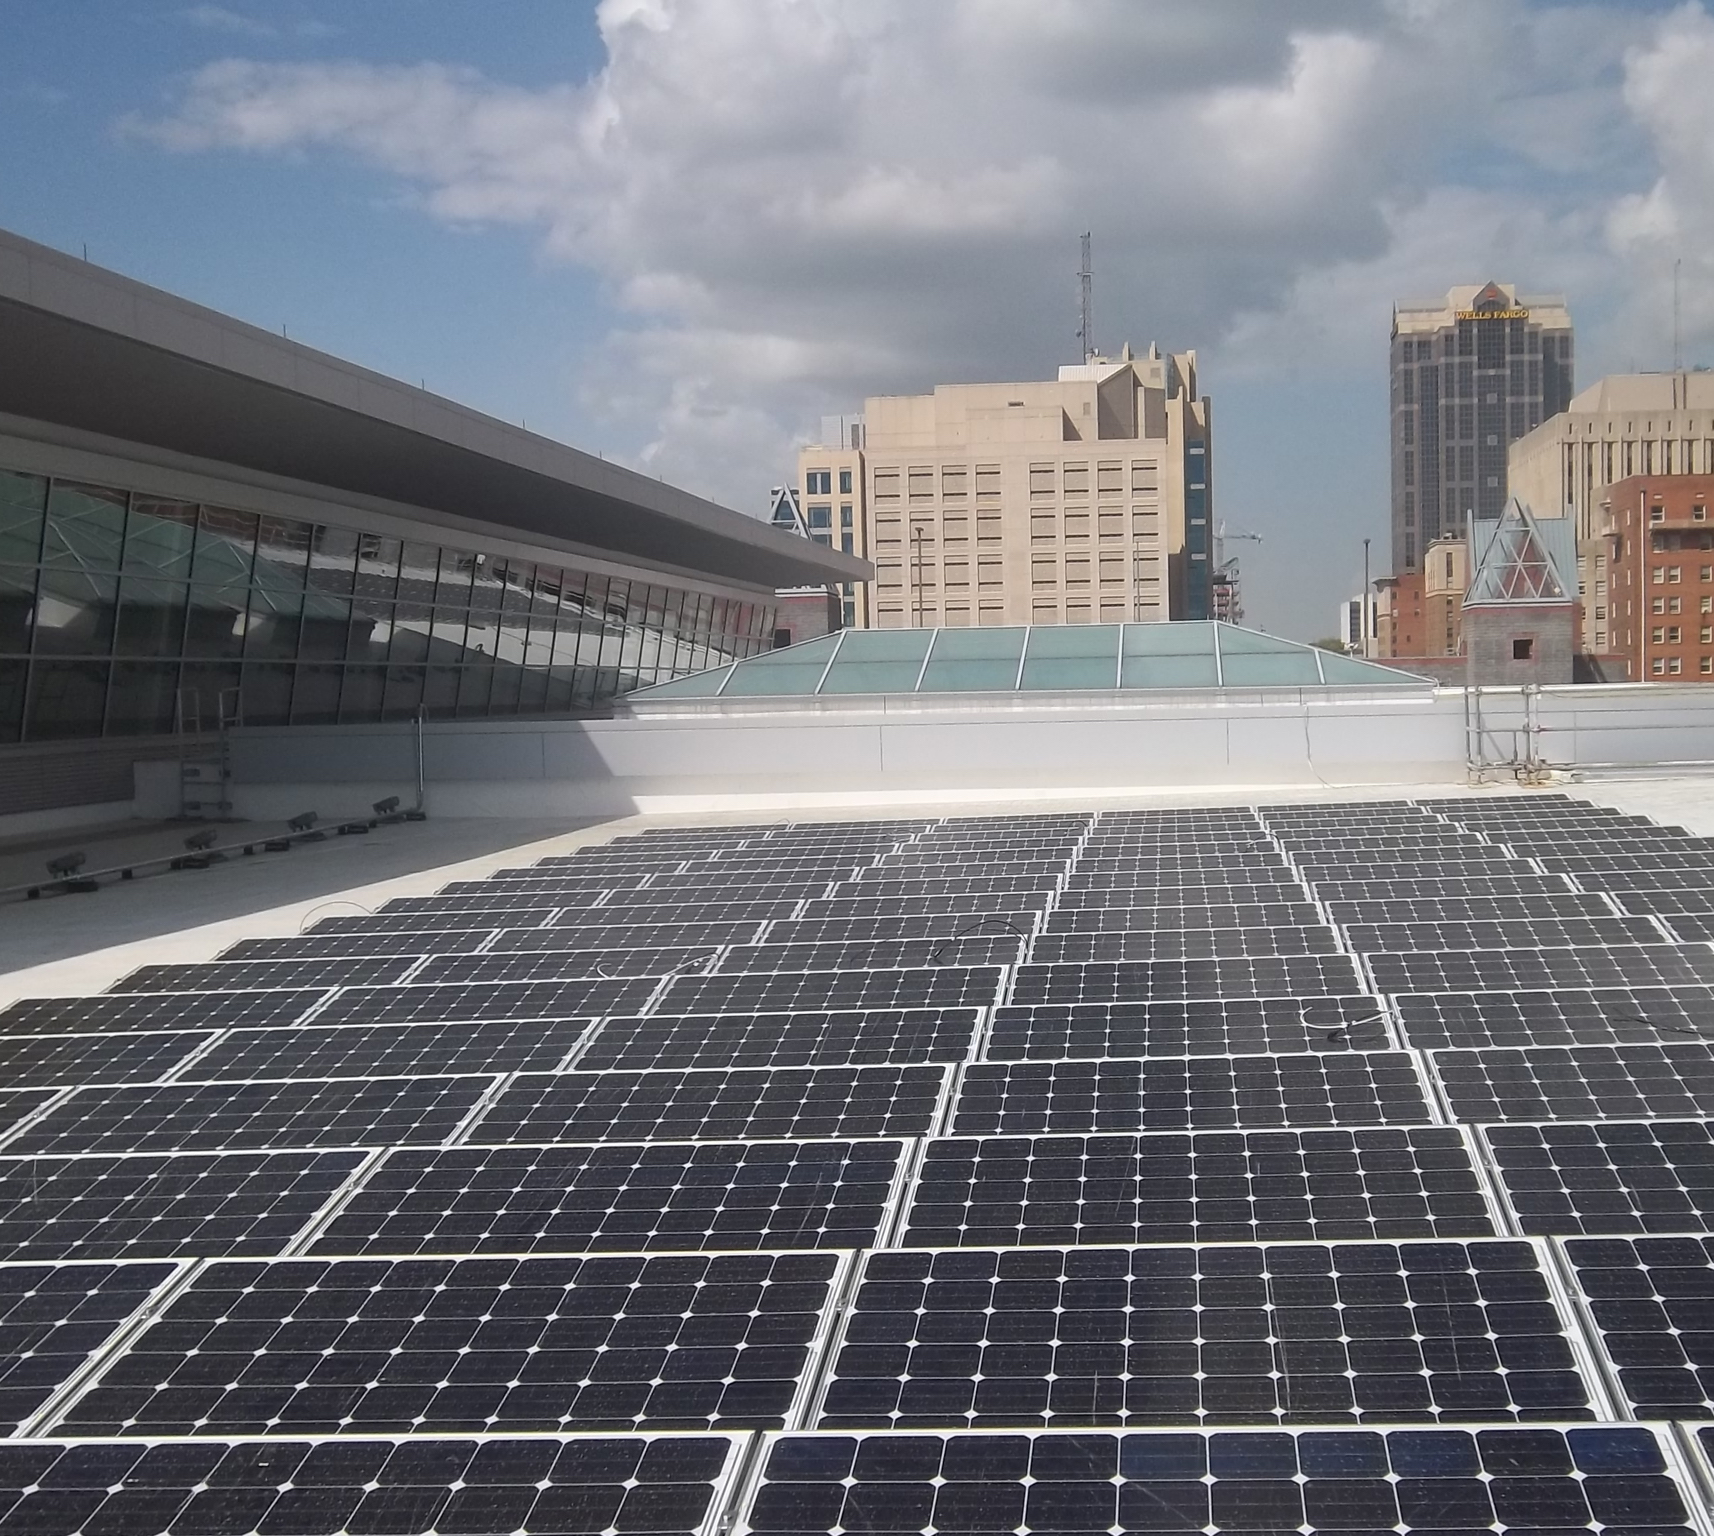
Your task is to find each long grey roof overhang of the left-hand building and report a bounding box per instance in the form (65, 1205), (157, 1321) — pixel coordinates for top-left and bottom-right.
(0, 233), (872, 588)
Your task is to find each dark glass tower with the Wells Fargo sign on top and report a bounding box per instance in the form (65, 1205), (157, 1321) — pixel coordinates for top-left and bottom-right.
(1392, 283), (1573, 574)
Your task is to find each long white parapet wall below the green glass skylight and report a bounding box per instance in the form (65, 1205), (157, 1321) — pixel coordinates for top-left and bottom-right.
(217, 687), (1467, 818)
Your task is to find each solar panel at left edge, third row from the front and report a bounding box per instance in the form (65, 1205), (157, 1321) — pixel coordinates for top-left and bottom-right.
(0, 1152), (365, 1260)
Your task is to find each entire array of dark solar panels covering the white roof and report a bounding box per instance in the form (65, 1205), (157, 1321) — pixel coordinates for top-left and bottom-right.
(10, 794), (1714, 1536)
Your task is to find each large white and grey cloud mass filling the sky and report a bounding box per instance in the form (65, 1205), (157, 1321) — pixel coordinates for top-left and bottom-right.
(130, 0), (1714, 620)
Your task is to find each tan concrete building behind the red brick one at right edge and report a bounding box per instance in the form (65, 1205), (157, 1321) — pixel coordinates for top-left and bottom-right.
(1508, 372), (1714, 655)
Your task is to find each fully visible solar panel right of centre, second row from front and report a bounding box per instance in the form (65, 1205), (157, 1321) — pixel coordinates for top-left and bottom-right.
(816, 1241), (1591, 1430)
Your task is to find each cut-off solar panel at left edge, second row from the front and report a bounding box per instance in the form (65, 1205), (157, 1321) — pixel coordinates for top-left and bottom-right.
(0, 1263), (178, 1435)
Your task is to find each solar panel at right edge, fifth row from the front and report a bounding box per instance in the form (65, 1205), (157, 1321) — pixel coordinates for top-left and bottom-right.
(1397, 987), (1714, 1051)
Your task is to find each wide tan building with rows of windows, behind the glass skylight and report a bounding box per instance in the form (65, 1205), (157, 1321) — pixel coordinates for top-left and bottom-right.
(799, 348), (1212, 629)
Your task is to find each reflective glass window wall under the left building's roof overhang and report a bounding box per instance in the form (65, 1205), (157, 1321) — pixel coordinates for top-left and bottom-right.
(0, 468), (773, 742)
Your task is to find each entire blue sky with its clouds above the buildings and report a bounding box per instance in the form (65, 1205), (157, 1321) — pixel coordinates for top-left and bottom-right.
(0, 0), (1714, 638)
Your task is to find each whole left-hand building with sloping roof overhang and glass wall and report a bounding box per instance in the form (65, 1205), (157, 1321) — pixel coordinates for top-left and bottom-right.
(0, 226), (867, 814)
